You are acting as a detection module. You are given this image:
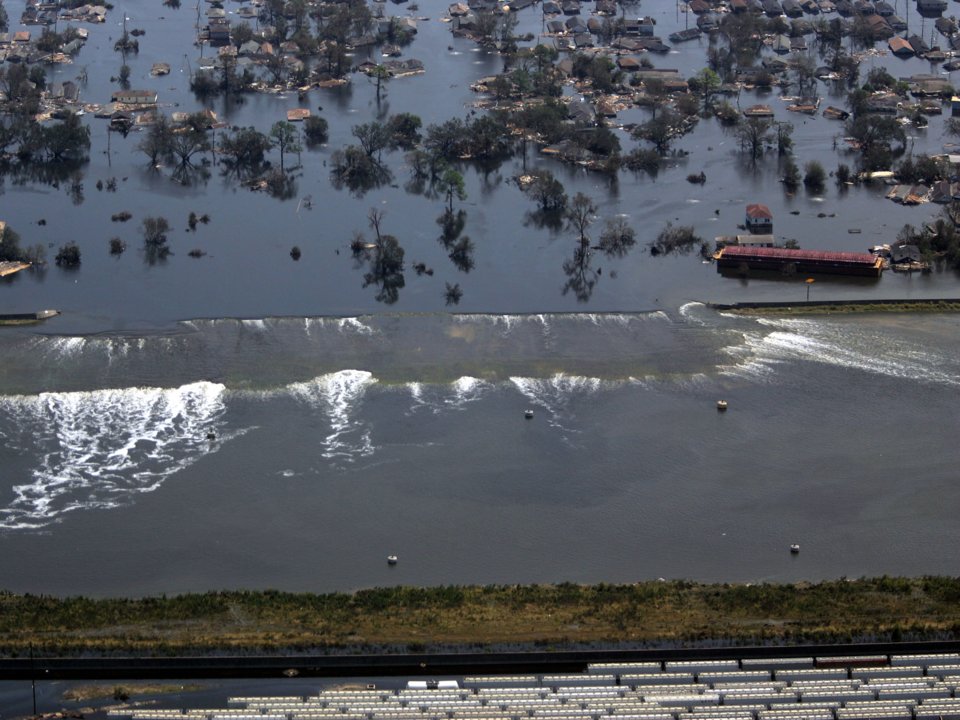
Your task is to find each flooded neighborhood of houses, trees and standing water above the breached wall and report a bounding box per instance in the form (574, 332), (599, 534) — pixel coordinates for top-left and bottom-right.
(0, 0), (960, 329)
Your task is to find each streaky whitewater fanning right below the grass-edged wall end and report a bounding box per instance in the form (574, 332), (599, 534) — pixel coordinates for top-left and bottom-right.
(720, 318), (960, 386)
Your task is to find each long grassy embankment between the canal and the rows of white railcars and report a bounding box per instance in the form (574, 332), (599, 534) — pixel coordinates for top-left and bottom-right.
(0, 577), (960, 657)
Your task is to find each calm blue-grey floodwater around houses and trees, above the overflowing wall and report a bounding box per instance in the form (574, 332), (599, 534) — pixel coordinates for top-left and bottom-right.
(0, 3), (956, 333)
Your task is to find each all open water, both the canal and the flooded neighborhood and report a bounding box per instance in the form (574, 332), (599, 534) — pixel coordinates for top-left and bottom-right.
(0, 2), (960, 595)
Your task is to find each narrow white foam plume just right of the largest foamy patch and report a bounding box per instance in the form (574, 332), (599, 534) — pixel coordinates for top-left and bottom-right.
(287, 370), (377, 462)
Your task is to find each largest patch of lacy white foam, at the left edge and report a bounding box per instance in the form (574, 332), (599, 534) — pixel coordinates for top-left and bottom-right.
(0, 382), (229, 529)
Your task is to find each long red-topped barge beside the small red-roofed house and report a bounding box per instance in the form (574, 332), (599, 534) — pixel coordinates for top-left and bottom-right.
(713, 245), (883, 277)
